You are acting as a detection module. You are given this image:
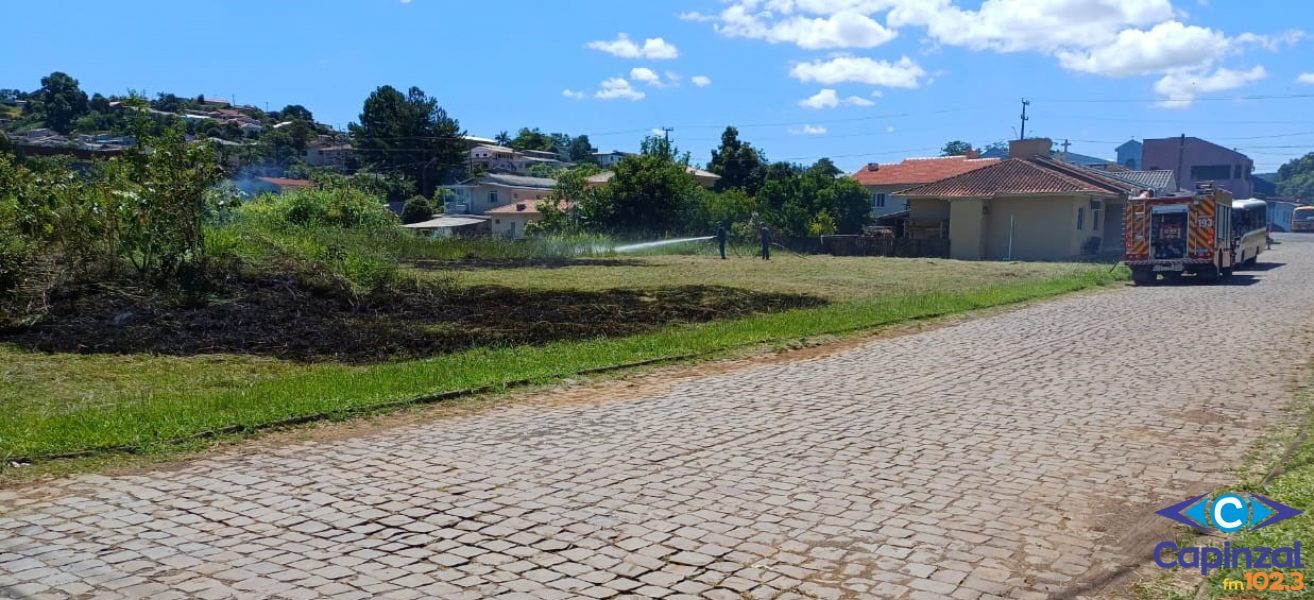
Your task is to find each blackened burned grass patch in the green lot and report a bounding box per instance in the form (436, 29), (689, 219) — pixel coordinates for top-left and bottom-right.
(0, 277), (827, 364)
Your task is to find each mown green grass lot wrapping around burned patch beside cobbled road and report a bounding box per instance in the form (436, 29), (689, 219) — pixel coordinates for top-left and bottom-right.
(0, 255), (1122, 462)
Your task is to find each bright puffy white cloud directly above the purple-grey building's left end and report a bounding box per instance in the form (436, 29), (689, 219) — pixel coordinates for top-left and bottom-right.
(1058, 21), (1227, 77)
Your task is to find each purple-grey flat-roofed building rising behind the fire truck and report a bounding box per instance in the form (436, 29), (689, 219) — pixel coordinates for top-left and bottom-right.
(1144, 135), (1255, 198)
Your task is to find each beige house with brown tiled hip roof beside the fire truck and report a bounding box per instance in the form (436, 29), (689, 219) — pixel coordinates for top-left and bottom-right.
(900, 139), (1135, 260)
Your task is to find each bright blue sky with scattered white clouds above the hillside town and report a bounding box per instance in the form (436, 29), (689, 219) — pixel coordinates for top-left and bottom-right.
(0, 0), (1314, 171)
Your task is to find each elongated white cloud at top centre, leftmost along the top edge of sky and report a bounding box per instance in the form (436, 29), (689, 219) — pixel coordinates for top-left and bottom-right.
(716, 7), (897, 50)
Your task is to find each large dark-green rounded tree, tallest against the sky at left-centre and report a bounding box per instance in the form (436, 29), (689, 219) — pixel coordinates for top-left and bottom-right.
(350, 85), (465, 196)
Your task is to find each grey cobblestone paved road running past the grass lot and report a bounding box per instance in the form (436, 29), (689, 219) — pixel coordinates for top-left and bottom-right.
(0, 238), (1314, 599)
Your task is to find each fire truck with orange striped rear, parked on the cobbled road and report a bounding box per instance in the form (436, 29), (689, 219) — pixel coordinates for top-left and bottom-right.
(1122, 184), (1235, 285)
